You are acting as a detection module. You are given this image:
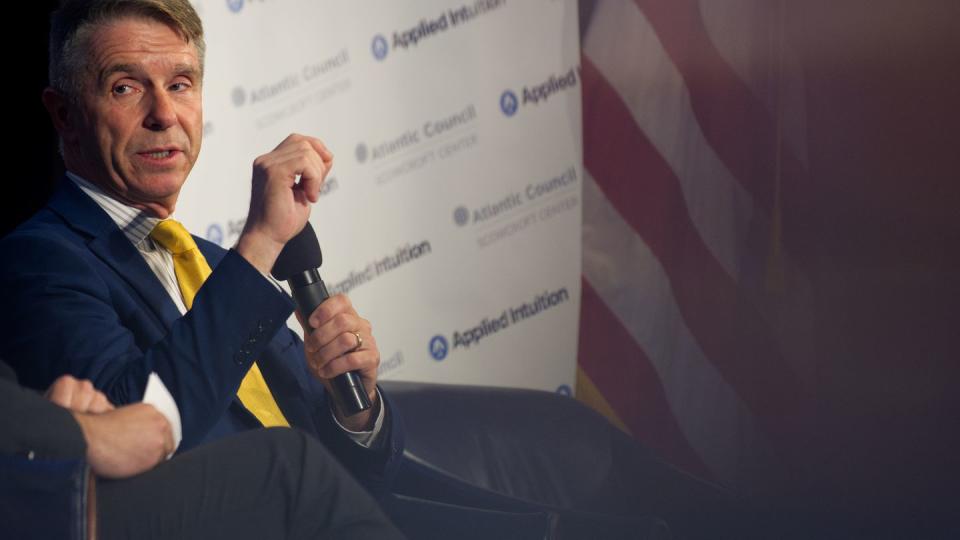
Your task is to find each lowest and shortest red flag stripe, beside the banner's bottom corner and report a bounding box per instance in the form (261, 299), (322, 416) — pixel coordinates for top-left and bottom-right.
(578, 279), (711, 479)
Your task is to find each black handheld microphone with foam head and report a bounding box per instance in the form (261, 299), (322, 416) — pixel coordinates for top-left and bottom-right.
(270, 221), (370, 416)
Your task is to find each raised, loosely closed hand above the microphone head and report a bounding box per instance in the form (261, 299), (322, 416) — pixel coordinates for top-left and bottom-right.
(237, 134), (333, 274)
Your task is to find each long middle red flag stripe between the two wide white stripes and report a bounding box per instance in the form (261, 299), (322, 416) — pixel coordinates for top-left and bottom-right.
(581, 57), (809, 464)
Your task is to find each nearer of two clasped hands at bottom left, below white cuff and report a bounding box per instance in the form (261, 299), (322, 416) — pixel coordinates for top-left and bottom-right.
(73, 403), (174, 478)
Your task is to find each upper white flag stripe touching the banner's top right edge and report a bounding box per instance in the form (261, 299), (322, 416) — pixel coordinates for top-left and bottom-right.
(583, 0), (753, 280)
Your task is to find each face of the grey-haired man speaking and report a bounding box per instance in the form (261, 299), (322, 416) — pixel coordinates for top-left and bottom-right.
(64, 18), (203, 217)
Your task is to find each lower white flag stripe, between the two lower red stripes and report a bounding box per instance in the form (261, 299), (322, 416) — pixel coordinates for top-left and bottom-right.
(583, 173), (770, 486)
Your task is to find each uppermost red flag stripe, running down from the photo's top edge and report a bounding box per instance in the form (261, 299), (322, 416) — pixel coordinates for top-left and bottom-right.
(634, 0), (813, 265)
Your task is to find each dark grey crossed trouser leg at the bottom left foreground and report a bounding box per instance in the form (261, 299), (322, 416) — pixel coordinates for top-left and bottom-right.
(97, 428), (402, 540)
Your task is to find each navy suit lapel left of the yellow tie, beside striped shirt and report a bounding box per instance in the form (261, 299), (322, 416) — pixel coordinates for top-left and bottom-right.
(49, 178), (180, 332)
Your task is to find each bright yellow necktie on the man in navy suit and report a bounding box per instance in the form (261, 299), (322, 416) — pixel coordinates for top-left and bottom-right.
(150, 219), (290, 427)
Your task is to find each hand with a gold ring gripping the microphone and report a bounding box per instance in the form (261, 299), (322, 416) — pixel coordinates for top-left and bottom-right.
(300, 294), (380, 431)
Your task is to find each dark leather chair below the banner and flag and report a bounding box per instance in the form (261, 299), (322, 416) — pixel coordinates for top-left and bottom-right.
(382, 381), (740, 539)
